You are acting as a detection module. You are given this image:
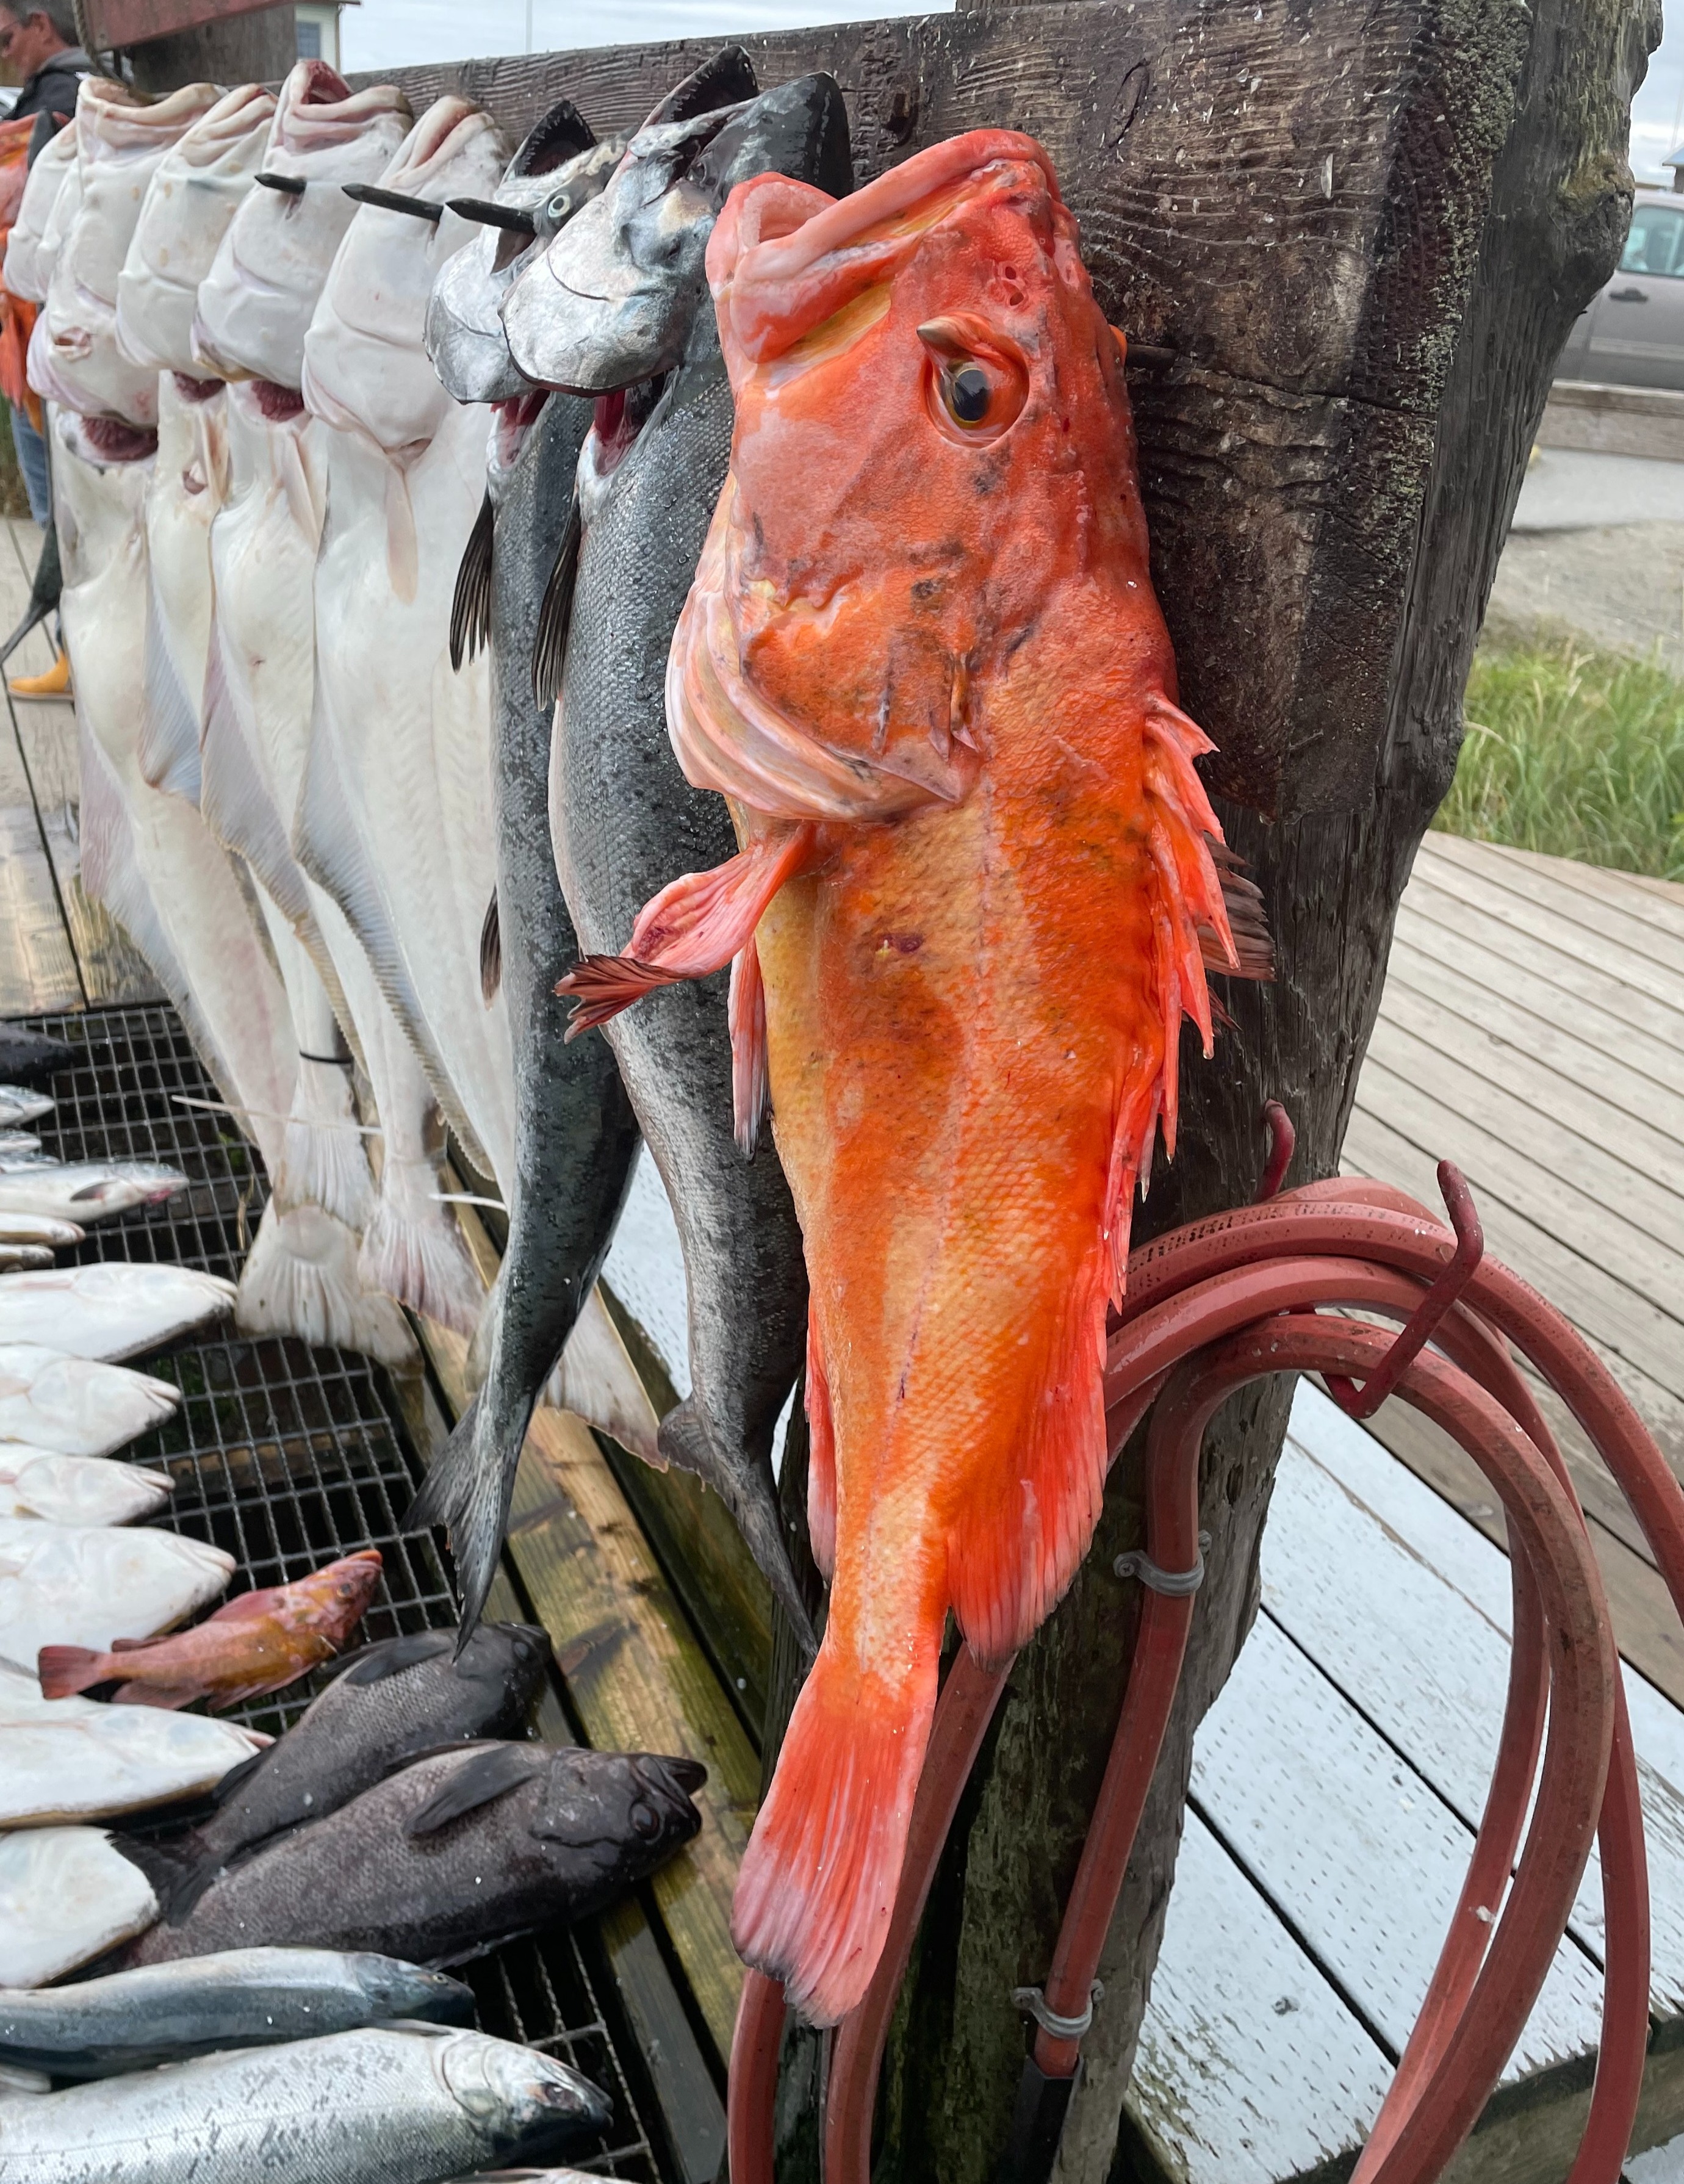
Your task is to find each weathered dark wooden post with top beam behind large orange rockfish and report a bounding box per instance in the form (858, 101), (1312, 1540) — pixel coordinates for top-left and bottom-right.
(371, 0), (1660, 2184)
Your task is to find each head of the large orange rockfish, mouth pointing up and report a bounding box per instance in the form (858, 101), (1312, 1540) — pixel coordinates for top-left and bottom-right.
(668, 129), (1173, 821)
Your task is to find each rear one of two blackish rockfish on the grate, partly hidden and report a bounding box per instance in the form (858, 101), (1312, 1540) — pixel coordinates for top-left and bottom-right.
(177, 1623), (550, 1881)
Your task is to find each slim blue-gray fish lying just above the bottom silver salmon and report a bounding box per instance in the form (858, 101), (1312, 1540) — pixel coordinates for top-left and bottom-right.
(0, 1948), (474, 2077)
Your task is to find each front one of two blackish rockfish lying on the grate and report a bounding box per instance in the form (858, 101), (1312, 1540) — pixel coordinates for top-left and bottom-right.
(124, 1745), (708, 1968)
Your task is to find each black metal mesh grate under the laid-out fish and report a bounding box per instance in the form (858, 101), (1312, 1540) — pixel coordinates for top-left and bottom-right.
(16, 1007), (662, 2184)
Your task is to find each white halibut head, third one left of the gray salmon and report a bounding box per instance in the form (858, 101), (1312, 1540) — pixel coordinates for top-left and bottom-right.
(118, 83), (275, 373)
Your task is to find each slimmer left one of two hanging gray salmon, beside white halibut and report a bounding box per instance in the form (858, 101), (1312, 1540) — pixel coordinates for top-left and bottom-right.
(408, 107), (638, 1632)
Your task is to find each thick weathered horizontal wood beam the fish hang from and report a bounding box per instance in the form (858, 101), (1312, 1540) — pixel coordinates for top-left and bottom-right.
(356, 0), (1522, 812)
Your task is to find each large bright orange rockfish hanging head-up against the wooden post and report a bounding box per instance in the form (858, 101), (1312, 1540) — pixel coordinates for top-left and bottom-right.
(572, 131), (1267, 2025)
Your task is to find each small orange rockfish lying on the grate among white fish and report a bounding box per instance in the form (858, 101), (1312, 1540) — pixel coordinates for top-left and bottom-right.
(37, 1546), (380, 1712)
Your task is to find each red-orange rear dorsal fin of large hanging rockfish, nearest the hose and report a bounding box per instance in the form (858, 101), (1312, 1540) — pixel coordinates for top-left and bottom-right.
(948, 1238), (1110, 1667)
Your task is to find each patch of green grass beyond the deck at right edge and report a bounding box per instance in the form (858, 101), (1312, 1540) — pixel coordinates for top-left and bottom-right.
(1433, 631), (1684, 880)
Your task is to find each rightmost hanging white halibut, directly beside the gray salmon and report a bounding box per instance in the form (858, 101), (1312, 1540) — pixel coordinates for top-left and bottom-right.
(293, 98), (516, 1203)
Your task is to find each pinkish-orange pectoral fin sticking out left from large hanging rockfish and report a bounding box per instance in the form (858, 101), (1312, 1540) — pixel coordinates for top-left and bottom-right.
(555, 823), (817, 1040)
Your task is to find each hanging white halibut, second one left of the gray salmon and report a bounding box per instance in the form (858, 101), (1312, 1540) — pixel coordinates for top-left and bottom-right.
(195, 61), (481, 1332)
